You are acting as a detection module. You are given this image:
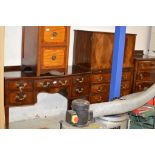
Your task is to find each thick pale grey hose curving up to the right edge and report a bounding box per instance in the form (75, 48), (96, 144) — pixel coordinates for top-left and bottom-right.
(90, 84), (155, 117)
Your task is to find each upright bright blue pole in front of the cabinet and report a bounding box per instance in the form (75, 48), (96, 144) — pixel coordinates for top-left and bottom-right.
(109, 26), (126, 100)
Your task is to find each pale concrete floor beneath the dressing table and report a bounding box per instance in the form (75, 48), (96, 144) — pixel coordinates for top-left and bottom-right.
(9, 115), (65, 129)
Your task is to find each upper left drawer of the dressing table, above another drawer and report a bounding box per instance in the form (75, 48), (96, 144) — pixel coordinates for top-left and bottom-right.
(6, 80), (33, 90)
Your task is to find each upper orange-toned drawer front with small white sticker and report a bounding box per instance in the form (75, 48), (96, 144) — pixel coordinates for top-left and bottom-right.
(42, 26), (67, 44)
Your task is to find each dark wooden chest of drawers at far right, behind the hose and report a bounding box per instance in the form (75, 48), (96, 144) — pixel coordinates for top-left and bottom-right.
(133, 55), (155, 92)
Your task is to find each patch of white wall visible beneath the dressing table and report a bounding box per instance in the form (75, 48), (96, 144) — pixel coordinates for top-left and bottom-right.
(10, 93), (68, 122)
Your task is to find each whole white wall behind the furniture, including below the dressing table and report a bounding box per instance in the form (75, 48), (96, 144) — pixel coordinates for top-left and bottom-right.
(4, 26), (149, 121)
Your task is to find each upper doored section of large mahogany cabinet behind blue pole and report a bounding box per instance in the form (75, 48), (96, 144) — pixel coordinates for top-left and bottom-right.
(73, 30), (136, 71)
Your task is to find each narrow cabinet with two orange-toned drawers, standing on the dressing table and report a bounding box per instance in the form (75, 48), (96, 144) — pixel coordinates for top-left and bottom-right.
(22, 26), (70, 76)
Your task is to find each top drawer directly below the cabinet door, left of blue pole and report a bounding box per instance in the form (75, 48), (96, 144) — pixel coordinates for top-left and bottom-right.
(91, 73), (111, 83)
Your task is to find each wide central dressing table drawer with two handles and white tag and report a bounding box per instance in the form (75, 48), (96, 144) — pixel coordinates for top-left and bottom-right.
(34, 78), (70, 90)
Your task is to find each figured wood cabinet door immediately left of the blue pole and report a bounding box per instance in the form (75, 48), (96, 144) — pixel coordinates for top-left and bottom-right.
(91, 32), (114, 70)
